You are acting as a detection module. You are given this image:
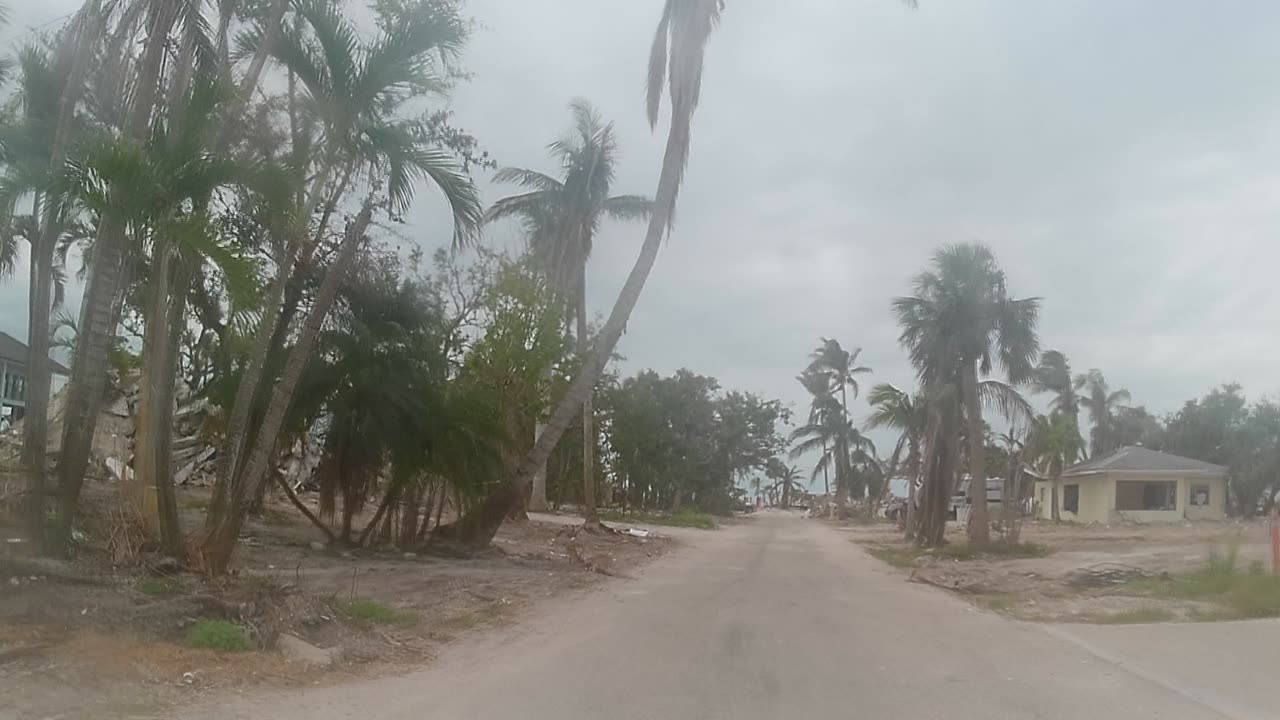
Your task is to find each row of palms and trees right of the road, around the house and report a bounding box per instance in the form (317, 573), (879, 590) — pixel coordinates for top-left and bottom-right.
(792, 243), (1280, 546)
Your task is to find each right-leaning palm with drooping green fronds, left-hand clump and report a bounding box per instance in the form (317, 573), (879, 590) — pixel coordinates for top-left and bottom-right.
(201, 0), (483, 574)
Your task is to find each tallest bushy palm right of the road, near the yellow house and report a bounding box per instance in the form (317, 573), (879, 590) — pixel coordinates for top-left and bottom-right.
(893, 243), (1039, 546)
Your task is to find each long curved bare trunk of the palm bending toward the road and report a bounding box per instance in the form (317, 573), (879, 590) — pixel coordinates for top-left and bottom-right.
(445, 114), (690, 546)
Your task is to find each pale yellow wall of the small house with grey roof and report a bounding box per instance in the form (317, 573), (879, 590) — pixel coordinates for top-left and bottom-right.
(1036, 473), (1226, 523)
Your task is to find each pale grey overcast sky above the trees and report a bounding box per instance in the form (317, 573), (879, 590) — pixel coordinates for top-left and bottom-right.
(0, 0), (1280, 458)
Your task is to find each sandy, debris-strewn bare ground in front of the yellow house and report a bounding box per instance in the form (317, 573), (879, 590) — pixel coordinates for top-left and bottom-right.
(847, 520), (1271, 621)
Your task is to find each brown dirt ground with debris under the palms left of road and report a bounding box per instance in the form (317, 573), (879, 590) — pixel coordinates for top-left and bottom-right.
(0, 492), (675, 720)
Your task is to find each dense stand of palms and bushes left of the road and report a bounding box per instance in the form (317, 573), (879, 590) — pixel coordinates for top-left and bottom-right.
(0, 0), (737, 574)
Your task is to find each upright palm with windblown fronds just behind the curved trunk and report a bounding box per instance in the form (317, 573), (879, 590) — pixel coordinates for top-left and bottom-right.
(485, 100), (653, 515)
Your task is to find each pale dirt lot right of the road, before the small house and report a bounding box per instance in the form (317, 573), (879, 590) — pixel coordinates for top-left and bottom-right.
(850, 520), (1280, 623)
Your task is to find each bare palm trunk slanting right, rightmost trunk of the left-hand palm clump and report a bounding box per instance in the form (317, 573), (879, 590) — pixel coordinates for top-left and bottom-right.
(201, 197), (374, 575)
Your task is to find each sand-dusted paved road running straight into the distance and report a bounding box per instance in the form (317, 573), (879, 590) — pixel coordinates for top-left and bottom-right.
(188, 514), (1276, 720)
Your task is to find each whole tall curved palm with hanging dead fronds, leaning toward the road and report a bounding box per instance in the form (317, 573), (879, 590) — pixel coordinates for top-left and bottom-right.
(442, 0), (724, 544)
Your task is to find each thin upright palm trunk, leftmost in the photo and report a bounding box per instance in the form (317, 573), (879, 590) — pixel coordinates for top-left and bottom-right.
(20, 1), (102, 547)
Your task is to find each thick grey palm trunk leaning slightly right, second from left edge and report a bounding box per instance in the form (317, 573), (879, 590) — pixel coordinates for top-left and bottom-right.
(54, 0), (178, 551)
